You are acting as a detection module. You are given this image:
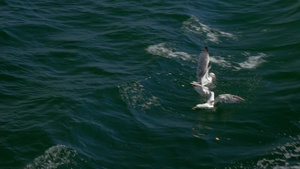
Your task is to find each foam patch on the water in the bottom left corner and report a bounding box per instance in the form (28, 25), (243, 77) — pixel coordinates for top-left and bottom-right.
(25, 145), (78, 169)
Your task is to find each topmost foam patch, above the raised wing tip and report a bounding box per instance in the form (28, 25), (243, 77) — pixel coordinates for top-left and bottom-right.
(182, 16), (236, 43)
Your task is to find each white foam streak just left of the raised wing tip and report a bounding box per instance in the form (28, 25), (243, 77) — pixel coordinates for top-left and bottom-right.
(146, 43), (193, 60)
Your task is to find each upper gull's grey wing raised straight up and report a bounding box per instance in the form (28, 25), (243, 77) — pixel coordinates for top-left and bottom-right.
(197, 47), (209, 83)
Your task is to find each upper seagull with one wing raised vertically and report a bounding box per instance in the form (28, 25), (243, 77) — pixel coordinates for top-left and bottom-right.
(197, 46), (216, 85)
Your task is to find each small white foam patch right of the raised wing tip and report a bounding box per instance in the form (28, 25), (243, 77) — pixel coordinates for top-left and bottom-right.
(237, 53), (267, 69)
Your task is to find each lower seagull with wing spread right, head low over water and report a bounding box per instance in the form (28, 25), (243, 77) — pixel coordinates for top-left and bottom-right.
(193, 91), (244, 109)
